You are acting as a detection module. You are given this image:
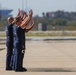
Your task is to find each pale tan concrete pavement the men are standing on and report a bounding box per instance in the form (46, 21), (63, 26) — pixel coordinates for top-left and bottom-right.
(0, 40), (76, 75)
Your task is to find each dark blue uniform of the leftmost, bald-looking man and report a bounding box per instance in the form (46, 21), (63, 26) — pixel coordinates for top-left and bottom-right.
(6, 24), (13, 70)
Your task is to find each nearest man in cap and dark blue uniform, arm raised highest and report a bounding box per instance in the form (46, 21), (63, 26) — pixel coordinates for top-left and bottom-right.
(12, 10), (32, 71)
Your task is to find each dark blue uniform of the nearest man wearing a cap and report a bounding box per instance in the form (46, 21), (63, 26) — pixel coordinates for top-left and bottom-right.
(12, 26), (22, 71)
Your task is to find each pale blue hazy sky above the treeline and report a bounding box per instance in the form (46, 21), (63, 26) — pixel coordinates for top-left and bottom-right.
(0, 0), (76, 16)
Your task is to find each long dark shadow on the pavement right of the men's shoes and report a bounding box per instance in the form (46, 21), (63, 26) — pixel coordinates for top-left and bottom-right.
(27, 68), (76, 72)
